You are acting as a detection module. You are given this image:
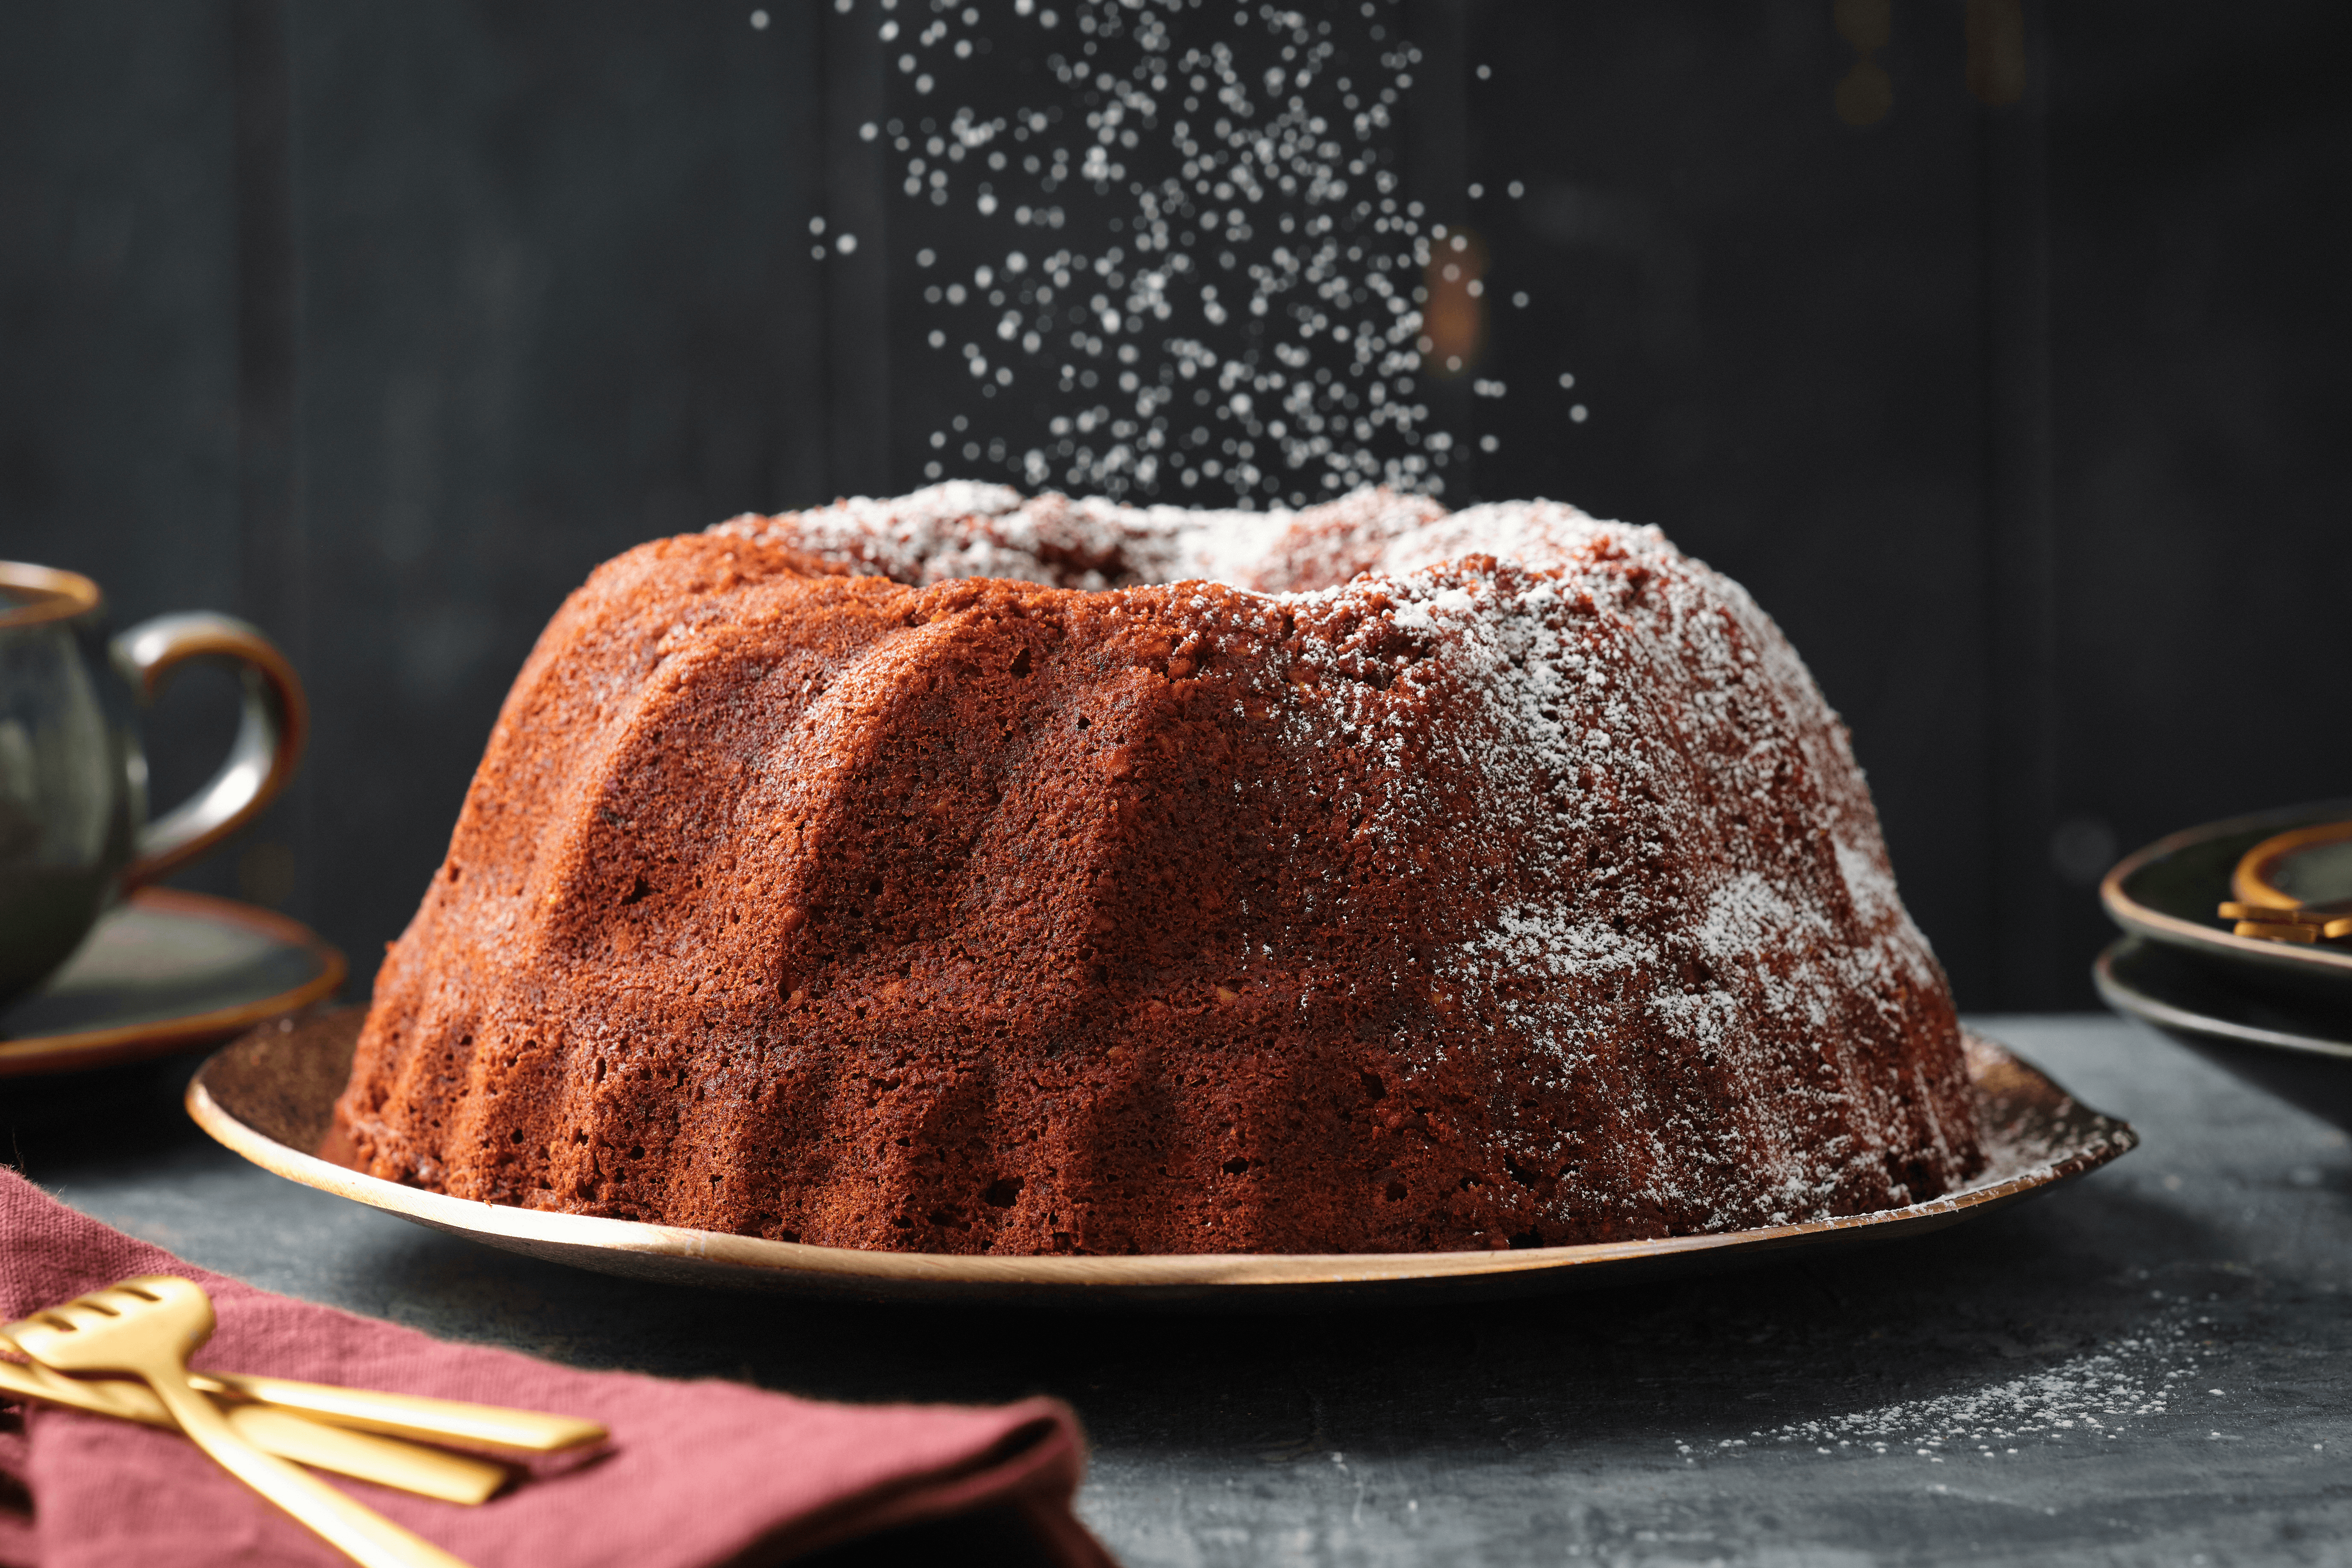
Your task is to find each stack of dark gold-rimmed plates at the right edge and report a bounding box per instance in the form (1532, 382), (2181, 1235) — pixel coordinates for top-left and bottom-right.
(2093, 801), (2352, 1128)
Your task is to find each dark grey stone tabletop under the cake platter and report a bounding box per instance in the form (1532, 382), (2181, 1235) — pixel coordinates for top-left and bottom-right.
(0, 1015), (2352, 1568)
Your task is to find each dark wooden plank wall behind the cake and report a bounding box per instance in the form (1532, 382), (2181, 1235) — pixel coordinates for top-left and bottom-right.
(0, 0), (2352, 1008)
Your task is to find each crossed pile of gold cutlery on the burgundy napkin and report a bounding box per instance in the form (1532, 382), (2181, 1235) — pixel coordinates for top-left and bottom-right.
(0, 1274), (604, 1568)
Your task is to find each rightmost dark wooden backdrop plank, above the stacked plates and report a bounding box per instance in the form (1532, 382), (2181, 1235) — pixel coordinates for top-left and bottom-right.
(2051, 0), (2352, 1006)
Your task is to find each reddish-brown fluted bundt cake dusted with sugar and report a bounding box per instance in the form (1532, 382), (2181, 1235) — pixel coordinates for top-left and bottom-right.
(336, 484), (1983, 1253)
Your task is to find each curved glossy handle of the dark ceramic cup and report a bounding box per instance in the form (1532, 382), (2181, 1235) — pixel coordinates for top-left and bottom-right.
(113, 611), (310, 893)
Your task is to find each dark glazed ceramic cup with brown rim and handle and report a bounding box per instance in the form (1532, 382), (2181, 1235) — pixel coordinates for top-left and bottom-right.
(0, 562), (308, 1004)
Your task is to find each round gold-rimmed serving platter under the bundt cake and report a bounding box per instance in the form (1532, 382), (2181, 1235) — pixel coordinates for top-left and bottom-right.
(188, 1008), (2138, 1309)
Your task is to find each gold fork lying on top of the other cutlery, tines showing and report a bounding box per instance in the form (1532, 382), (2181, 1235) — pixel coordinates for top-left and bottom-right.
(7, 1274), (466, 1568)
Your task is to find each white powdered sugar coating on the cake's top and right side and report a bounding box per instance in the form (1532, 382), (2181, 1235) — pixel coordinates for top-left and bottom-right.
(717, 472), (1973, 1225)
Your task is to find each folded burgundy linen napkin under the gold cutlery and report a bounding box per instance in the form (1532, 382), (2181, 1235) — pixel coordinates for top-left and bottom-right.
(0, 1168), (1110, 1568)
